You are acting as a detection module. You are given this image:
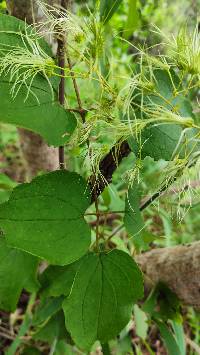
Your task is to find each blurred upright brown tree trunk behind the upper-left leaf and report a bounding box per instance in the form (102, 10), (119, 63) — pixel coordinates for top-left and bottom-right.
(7, 0), (60, 179)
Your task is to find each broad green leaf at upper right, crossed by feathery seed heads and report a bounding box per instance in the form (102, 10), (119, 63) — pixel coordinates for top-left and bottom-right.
(131, 69), (198, 161)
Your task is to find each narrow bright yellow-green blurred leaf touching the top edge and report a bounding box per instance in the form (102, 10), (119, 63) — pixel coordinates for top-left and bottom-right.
(124, 0), (139, 39)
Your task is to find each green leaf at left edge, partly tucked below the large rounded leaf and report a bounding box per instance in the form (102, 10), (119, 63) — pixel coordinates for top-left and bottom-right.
(0, 238), (38, 312)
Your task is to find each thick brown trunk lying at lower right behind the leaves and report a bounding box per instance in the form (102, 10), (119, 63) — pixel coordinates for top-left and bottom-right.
(136, 241), (200, 308)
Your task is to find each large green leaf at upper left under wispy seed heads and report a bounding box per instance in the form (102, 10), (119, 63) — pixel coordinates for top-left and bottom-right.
(0, 15), (76, 146)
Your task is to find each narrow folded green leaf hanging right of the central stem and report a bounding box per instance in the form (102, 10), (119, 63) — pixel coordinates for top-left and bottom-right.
(124, 183), (144, 243)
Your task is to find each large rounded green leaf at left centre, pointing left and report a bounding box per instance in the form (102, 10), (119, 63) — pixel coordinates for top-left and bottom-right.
(0, 171), (90, 265)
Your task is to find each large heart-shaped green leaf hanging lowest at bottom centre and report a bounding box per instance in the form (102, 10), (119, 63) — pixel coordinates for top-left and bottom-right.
(63, 250), (143, 350)
